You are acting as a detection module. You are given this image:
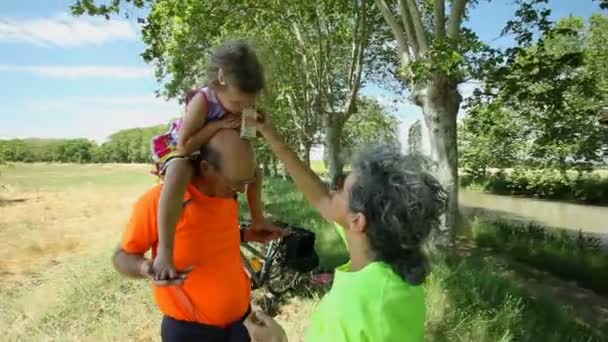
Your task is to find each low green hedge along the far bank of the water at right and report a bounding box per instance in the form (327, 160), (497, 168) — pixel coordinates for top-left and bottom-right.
(460, 169), (608, 205)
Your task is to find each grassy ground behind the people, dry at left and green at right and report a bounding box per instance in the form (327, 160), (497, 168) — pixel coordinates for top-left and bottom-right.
(0, 164), (608, 342)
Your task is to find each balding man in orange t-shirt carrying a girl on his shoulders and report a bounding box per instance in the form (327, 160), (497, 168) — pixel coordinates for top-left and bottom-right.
(113, 130), (279, 342)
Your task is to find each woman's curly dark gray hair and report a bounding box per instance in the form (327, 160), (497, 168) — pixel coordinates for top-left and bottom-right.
(349, 145), (446, 285)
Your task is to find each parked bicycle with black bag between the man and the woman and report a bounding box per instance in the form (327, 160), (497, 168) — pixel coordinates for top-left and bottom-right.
(241, 221), (319, 296)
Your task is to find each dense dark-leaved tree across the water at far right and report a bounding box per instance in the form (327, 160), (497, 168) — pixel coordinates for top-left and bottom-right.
(460, 10), (608, 173)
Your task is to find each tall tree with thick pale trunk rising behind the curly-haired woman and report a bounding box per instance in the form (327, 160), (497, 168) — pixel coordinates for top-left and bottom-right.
(374, 0), (476, 236)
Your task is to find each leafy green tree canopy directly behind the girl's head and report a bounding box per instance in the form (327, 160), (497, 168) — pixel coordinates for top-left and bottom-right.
(67, 0), (382, 180)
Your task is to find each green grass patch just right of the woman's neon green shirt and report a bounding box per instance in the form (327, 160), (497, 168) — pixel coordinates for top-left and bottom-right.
(427, 254), (608, 341)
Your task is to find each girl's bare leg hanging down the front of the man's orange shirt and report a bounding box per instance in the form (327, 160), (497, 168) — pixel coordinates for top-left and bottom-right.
(153, 158), (194, 280)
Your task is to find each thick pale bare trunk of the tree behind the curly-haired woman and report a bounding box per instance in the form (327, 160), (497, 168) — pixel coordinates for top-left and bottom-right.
(415, 78), (462, 246)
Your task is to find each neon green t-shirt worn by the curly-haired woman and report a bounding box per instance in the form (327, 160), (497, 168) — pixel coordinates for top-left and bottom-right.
(306, 225), (426, 342)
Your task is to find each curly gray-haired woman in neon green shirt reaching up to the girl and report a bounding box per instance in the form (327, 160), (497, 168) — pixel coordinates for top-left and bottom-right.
(246, 115), (446, 342)
